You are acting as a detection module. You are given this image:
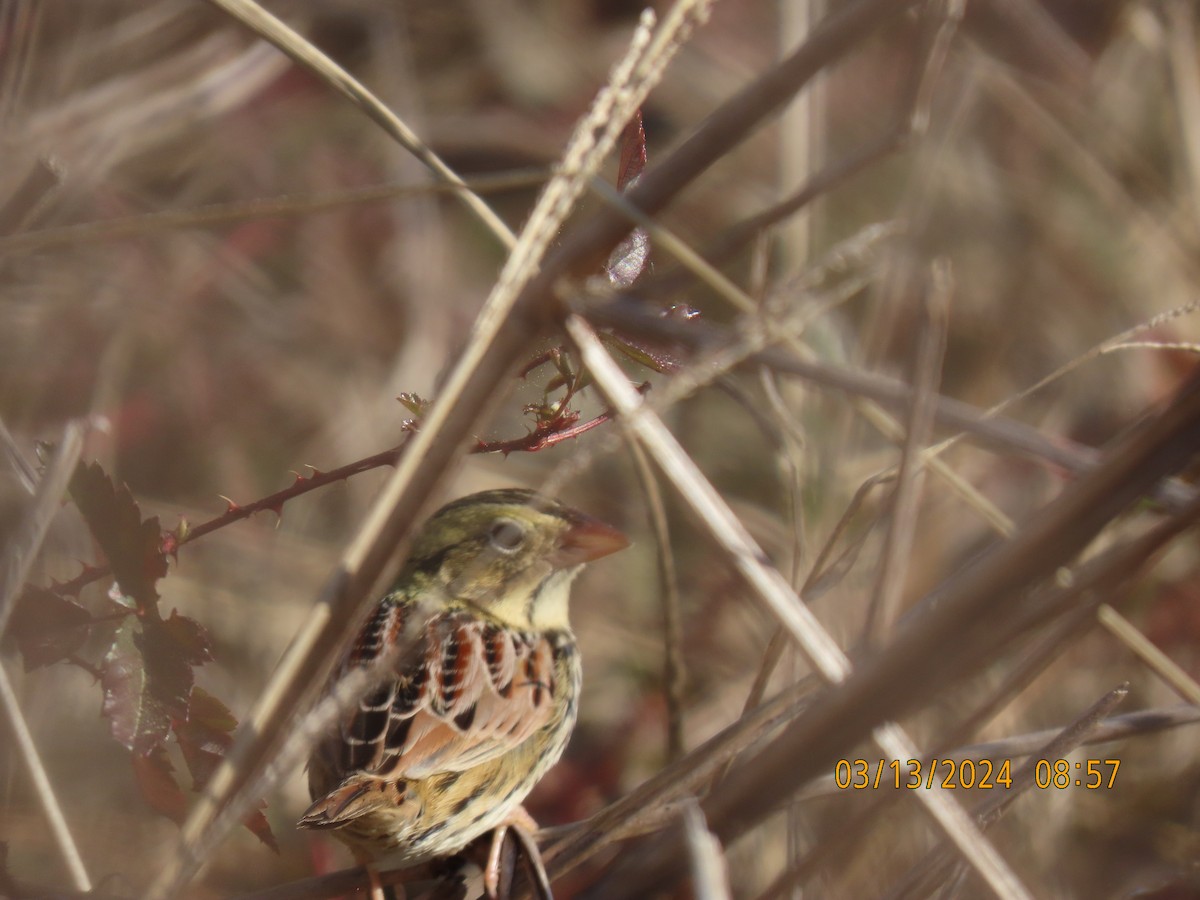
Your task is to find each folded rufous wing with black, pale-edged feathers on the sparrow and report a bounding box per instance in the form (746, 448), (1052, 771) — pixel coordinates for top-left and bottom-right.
(324, 604), (570, 779)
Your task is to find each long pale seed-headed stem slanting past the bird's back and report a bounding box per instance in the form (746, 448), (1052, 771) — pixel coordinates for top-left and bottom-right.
(148, 5), (694, 898)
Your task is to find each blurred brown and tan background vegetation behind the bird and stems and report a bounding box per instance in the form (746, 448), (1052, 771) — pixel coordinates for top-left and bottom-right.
(0, 0), (1200, 898)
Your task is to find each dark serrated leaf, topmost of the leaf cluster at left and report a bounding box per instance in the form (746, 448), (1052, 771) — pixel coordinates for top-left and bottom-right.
(70, 462), (167, 613)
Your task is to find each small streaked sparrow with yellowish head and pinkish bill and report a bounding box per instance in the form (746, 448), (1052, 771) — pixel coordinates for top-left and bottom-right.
(299, 490), (629, 892)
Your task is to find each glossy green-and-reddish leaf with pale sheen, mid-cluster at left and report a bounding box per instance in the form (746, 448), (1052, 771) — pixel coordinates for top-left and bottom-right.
(101, 616), (192, 756)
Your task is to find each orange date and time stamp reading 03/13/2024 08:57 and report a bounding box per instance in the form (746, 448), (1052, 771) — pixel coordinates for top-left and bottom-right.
(833, 757), (1121, 791)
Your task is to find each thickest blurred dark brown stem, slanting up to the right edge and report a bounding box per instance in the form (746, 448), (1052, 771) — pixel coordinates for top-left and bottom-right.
(614, 372), (1200, 884)
